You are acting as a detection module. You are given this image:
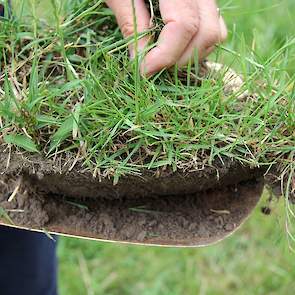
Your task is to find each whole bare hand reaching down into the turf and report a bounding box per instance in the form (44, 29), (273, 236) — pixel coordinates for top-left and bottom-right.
(106, 0), (227, 76)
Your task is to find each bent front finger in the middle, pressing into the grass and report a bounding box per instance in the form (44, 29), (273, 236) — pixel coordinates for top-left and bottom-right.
(141, 0), (199, 76)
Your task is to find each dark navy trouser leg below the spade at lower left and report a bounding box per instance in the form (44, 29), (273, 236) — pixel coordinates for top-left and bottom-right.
(0, 226), (57, 295)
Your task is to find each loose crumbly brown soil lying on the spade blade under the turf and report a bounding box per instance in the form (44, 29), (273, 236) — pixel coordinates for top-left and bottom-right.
(0, 176), (263, 246)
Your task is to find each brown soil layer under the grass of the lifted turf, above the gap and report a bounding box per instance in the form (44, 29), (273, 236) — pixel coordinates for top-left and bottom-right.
(0, 151), (264, 199)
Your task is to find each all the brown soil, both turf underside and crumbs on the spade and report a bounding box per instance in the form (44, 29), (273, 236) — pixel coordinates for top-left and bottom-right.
(0, 149), (263, 246)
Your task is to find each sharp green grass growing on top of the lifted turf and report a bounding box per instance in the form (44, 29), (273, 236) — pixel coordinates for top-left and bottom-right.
(0, 0), (295, 187)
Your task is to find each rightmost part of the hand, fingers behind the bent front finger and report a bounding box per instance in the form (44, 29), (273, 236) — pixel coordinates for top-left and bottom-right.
(177, 0), (227, 67)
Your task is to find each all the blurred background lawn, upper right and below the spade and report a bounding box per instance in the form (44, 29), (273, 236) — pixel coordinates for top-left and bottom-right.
(58, 0), (295, 295)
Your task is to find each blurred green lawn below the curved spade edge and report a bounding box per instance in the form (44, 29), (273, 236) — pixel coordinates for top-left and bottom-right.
(59, 195), (295, 295)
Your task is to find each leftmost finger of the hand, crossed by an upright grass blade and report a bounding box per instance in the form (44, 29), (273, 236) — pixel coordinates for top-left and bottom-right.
(106, 0), (150, 58)
